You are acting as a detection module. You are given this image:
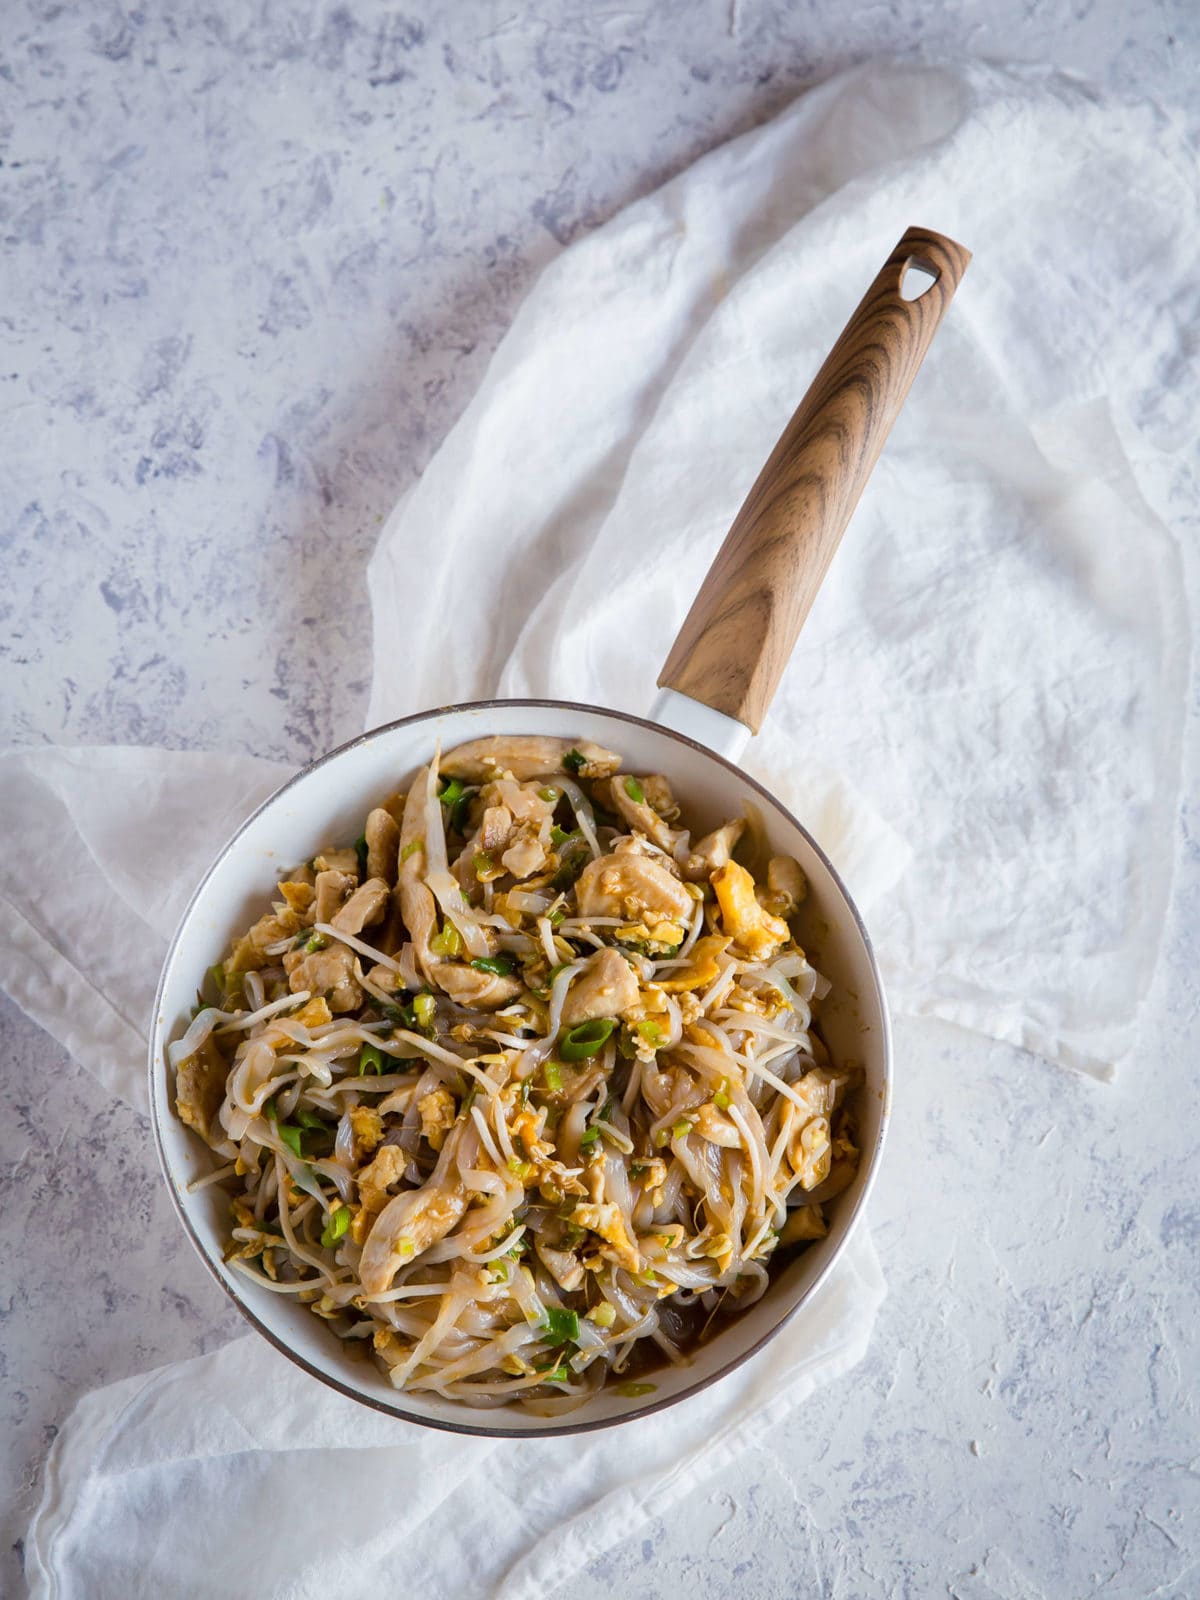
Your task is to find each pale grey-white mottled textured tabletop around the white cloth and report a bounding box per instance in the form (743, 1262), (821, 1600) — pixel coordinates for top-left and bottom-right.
(0, 0), (1200, 1600)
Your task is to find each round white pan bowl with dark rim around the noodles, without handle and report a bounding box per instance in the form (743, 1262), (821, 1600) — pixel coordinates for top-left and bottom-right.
(150, 701), (890, 1435)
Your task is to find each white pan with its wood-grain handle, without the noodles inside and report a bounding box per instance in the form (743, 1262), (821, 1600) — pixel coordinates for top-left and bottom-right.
(150, 229), (970, 1437)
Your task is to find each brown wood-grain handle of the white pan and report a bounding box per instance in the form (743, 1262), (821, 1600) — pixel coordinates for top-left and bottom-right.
(658, 227), (971, 733)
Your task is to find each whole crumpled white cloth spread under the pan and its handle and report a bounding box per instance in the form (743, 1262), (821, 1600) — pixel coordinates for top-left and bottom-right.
(0, 53), (1197, 1597)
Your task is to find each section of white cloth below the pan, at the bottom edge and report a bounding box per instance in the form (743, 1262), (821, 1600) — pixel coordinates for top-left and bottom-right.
(26, 1232), (885, 1600)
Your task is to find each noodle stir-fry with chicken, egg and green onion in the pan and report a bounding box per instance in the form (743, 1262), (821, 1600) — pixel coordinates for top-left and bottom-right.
(170, 738), (858, 1414)
